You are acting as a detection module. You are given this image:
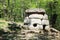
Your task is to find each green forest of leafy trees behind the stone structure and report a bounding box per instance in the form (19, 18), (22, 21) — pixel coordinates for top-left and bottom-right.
(0, 0), (60, 30)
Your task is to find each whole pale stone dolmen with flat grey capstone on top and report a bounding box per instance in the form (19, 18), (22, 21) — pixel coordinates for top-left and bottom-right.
(24, 8), (49, 30)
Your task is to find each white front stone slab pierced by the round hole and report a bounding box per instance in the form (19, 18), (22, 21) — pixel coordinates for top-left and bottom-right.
(29, 19), (43, 30)
